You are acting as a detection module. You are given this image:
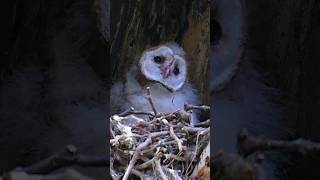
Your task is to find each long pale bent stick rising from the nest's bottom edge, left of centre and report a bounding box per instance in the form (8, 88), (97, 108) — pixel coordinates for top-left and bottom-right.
(122, 131), (169, 180)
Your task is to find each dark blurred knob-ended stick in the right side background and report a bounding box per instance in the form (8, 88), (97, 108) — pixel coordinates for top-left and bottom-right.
(238, 129), (320, 156)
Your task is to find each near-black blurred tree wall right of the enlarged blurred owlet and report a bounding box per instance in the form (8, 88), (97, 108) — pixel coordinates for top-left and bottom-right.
(243, 0), (320, 179)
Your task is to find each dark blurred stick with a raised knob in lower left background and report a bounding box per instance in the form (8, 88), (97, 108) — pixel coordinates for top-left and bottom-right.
(24, 145), (109, 174)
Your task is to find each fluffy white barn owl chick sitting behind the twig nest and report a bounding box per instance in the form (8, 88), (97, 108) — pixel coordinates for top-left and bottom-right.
(111, 42), (198, 124)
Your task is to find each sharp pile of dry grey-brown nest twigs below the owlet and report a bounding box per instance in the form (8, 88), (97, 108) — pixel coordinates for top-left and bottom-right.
(110, 88), (210, 180)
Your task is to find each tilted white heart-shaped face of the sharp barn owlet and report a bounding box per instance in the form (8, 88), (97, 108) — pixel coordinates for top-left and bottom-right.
(139, 46), (187, 91)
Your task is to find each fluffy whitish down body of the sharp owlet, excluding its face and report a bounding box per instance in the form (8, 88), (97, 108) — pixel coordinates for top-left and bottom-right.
(111, 43), (199, 123)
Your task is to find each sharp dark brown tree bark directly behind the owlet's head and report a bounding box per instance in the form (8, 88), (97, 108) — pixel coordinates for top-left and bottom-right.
(111, 0), (210, 103)
